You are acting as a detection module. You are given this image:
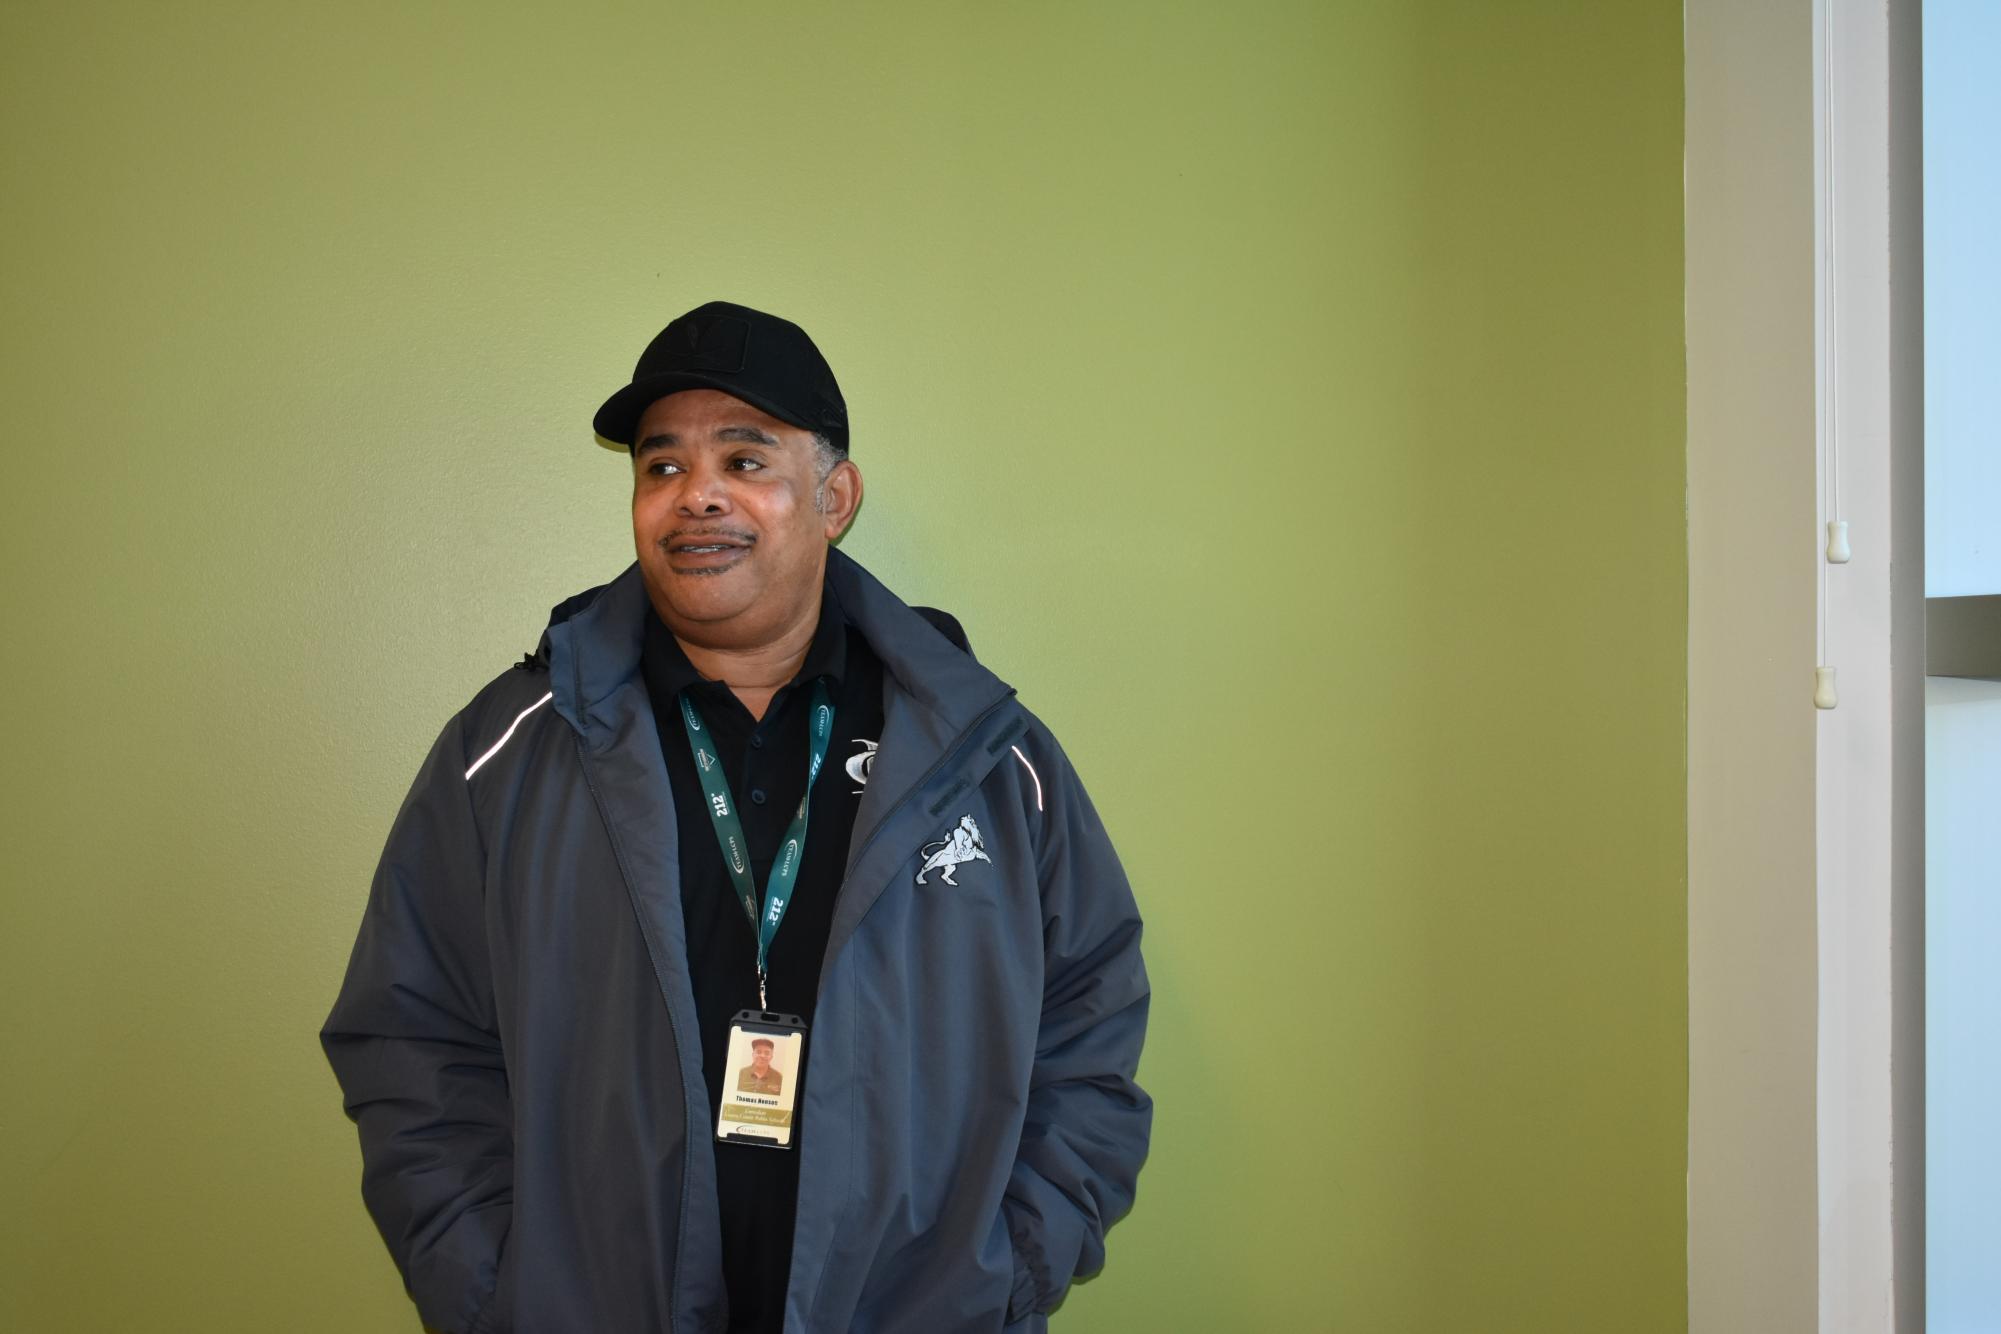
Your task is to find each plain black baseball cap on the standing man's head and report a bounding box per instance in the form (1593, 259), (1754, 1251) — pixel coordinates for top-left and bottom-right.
(590, 302), (848, 452)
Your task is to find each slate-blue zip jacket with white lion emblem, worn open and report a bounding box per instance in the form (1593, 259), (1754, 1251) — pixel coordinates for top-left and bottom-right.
(320, 552), (1153, 1334)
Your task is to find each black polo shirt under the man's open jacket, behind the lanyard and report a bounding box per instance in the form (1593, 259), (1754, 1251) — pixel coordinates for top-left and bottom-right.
(640, 590), (882, 1334)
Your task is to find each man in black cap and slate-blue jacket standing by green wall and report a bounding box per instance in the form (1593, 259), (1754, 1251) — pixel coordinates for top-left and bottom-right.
(322, 302), (1153, 1334)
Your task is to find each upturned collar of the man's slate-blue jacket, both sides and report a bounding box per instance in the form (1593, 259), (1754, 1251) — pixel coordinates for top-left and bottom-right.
(536, 548), (1013, 738)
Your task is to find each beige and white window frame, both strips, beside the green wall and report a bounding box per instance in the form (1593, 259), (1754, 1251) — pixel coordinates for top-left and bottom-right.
(1685, 0), (1923, 1334)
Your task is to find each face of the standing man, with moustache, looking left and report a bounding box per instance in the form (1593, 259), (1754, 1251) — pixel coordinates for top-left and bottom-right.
(632, 390), (860, 648)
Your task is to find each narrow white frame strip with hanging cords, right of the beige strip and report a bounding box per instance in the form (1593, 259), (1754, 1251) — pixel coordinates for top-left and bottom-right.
(1815, 0), (1925, 1334)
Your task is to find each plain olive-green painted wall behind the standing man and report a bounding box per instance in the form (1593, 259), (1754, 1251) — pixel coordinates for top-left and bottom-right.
(0, 0), (1687, 1334)
